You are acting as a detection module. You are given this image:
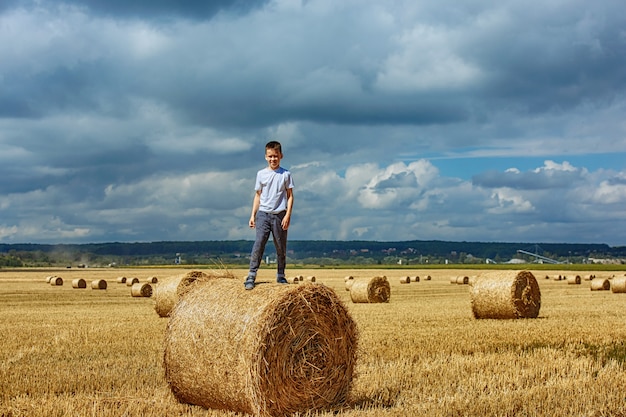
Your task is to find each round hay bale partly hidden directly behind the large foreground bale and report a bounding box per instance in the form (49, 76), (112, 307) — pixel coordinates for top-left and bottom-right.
(154, 270), (233, 317)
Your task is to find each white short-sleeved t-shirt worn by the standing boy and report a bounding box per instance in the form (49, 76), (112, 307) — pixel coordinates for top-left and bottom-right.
(254, 167), (293, 214)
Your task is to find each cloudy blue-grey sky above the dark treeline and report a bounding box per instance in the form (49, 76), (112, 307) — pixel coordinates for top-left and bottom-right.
(0, 0), (626, 246)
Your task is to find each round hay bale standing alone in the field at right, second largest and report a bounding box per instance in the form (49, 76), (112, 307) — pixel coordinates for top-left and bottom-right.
(470, 271), (541, 319)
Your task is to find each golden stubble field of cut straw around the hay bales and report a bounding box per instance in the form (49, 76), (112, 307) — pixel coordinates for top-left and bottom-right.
(0, 268), (626, 417)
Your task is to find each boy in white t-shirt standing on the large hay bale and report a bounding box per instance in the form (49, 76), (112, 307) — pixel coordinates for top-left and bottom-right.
(244, 141), (293, 290)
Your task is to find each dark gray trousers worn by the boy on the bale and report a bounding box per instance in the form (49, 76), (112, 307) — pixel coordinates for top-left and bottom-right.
(248, 210), (287, 278)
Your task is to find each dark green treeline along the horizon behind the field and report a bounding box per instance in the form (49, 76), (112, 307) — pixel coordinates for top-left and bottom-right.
(0, 240), (626, 267)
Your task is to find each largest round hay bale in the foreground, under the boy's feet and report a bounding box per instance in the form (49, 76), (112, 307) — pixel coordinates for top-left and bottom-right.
(164, 279), (358, 416)
